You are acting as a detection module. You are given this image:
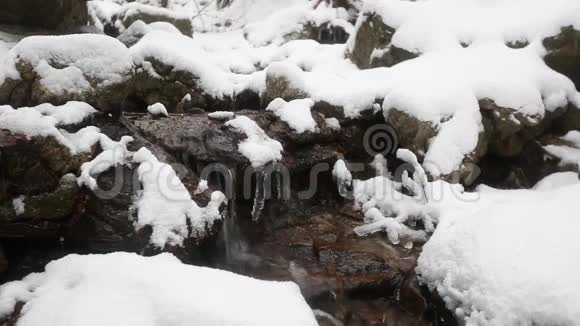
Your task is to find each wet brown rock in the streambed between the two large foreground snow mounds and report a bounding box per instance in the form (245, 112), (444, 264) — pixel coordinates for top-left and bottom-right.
(213, 200), (453, 325)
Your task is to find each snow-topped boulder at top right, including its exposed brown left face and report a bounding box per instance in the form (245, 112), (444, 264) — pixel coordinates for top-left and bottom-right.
(348, 0), (580, 68)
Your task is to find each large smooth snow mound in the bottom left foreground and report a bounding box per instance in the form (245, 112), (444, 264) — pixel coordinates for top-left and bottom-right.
(0, 252), (318, 326)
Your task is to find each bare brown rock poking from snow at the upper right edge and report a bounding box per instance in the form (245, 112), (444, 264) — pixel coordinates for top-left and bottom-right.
(543, 26), (580, 88)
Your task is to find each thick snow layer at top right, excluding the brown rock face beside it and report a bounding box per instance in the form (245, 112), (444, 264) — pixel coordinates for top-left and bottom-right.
(360, 0), (580, 53)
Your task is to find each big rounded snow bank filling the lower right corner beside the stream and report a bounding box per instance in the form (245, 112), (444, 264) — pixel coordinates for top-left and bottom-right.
(417, 183), (580, 325)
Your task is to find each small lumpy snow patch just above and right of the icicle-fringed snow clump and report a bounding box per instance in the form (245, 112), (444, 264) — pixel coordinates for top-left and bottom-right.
(266, 98), (317, 134)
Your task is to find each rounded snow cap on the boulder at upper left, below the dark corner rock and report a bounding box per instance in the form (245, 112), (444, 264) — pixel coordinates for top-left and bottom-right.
(0, 34), (133, 95)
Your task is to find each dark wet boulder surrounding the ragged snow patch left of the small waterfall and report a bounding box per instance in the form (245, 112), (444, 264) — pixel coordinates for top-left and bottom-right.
(66, 119), (220, 263)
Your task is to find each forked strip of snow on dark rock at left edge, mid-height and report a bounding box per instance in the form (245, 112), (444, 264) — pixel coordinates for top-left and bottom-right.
(0, 102), (99, 154)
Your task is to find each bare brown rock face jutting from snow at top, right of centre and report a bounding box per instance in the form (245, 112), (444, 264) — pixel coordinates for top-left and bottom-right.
(346, 12), (418, 69)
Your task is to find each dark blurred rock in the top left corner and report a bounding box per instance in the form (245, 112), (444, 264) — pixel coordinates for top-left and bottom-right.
(0, 0), (88, 31)
